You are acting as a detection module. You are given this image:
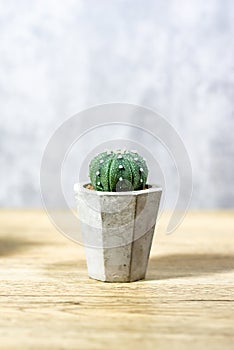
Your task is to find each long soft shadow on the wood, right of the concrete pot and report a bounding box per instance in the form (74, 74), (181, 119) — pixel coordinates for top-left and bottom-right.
(146, 253), (234, 280)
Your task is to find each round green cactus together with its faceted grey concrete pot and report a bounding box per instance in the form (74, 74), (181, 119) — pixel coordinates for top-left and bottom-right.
(74, 150), (162, 282)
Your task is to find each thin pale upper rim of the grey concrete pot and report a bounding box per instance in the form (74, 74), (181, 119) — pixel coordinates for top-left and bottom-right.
(73, 181), (162, 196)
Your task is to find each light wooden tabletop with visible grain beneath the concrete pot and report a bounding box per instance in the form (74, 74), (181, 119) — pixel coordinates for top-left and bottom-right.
(0, 210), (234, 350)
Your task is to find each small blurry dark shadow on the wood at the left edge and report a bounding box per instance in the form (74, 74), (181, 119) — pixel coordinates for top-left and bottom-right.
(0, 236), (41, 259)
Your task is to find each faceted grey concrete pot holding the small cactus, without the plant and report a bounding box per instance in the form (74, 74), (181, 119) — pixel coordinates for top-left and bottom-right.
(74, 183), (162, 282)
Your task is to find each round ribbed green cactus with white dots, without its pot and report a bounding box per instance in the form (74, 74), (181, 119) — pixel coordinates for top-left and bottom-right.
(89, 150), (148, 192)
